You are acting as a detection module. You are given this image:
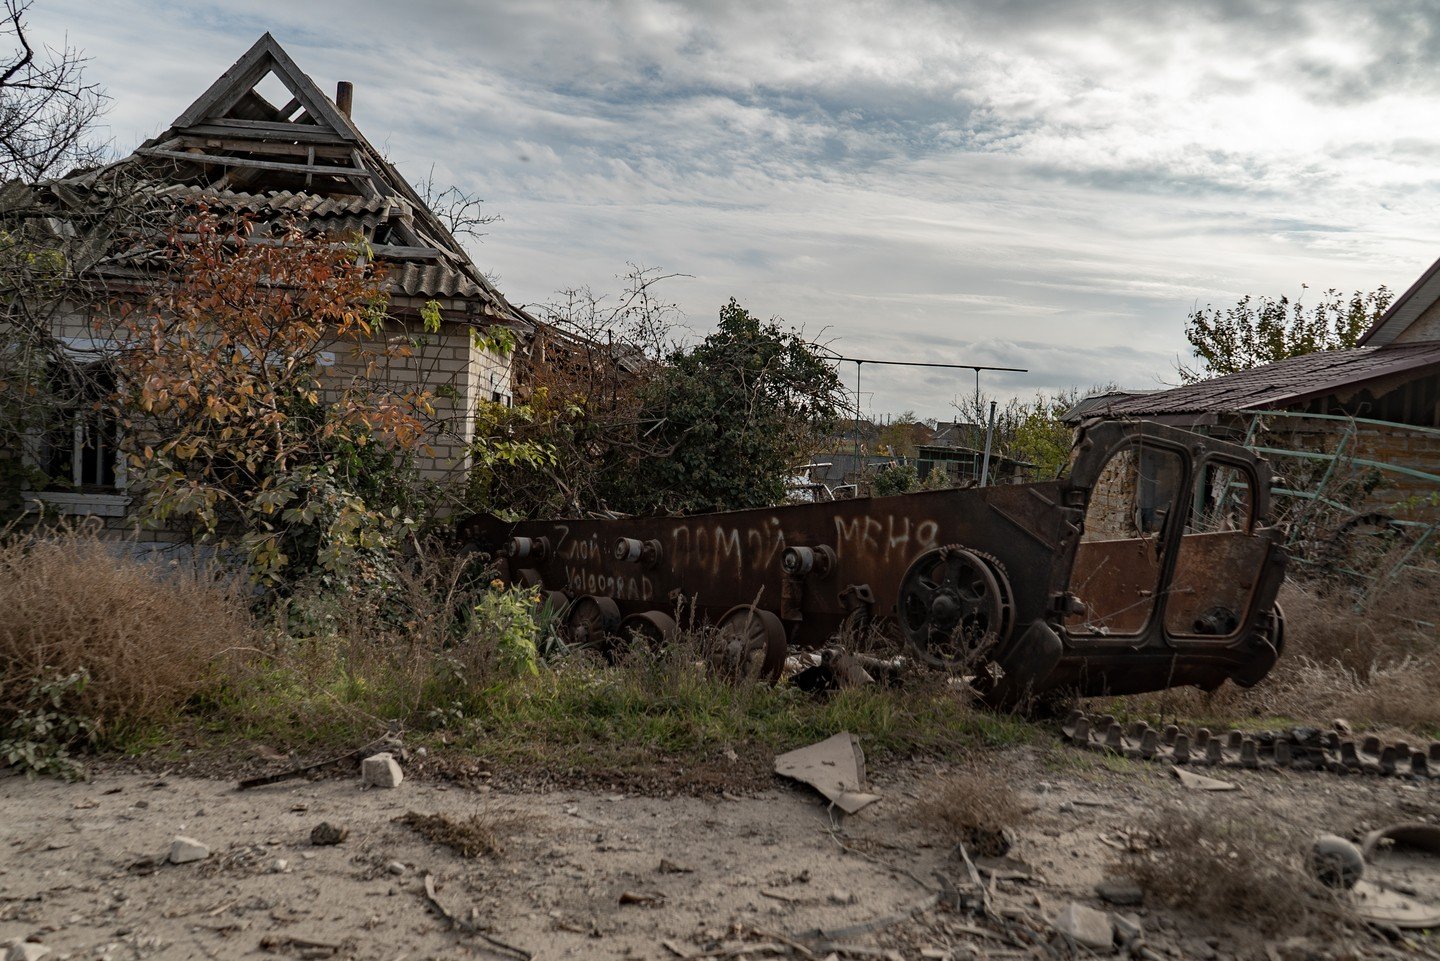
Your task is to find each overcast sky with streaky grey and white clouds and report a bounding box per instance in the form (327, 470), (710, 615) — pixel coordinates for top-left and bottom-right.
(30, 0), (1440, 419)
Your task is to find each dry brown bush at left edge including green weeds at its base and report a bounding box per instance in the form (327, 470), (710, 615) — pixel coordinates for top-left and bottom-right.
(0, 524), (253, 774)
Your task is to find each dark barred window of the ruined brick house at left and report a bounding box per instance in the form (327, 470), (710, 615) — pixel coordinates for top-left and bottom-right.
(36, 363), (124, 493)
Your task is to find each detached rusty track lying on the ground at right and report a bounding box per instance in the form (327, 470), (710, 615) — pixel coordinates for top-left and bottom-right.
(1061, 710), (1440, 781)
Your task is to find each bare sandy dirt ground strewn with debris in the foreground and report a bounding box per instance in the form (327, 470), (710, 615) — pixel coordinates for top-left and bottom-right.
(0, 745), (1440, 961)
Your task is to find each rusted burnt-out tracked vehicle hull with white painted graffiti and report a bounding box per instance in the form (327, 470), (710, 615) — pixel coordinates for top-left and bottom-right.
(461, 421), (1284, 705)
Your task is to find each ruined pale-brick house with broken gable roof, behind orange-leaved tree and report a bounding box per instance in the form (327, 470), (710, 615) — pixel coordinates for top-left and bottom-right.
(0, 33), (544, 540)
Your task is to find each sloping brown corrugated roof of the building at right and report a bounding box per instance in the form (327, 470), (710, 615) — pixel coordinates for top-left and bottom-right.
(1087, 343), (1440, 416)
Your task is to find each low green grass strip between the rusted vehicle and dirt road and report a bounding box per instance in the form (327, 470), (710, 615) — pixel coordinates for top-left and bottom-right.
(203, 640), (1032, 777)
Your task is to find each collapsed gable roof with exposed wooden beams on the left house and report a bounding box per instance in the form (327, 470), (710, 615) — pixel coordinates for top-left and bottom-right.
(0, 33), (536, 331)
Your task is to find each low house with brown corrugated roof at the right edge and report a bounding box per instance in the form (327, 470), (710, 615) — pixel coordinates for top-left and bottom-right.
(1066, 261), (1440, 520)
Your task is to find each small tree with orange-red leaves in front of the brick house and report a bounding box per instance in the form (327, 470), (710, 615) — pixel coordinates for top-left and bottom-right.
(117, 209), (439, 585)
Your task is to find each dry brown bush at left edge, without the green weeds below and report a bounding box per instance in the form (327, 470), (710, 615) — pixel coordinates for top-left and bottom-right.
(0, 526), (251, 736)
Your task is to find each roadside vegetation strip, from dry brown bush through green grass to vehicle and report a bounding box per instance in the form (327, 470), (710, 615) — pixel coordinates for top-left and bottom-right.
(0, 539), (1032, 788)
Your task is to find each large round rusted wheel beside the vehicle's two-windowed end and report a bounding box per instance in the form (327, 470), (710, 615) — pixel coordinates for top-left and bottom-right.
(897, 546), (1014, 671)
